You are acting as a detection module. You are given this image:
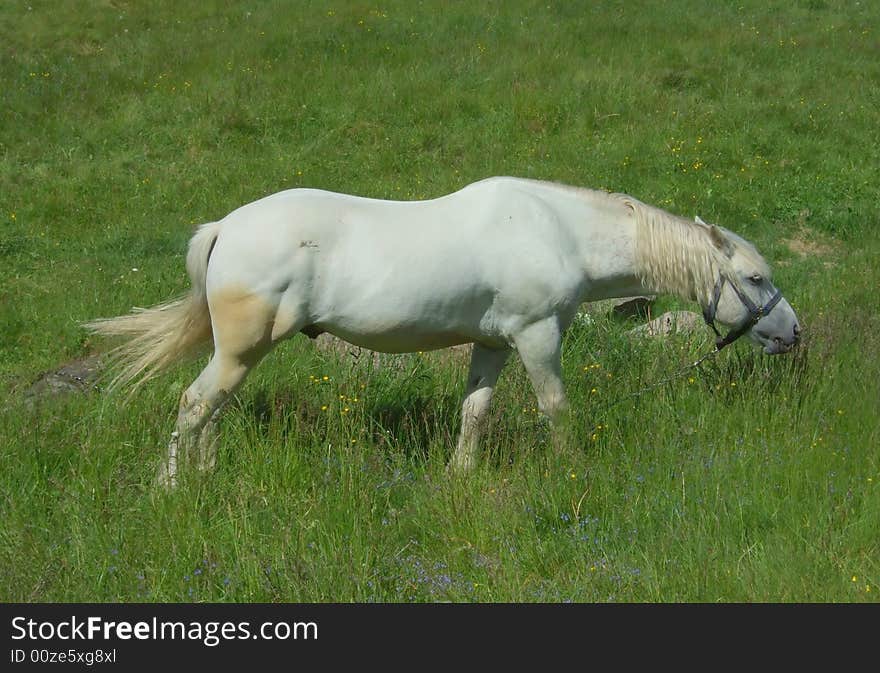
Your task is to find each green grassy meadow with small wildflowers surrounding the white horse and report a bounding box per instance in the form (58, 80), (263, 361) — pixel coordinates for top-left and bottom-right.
(0, 0), (880, 601)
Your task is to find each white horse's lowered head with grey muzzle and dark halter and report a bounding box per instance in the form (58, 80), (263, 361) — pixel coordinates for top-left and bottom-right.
(697, 218), (801, 355)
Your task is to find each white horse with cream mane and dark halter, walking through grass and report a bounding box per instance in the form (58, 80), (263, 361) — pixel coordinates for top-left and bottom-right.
(87, 177), (800, 485)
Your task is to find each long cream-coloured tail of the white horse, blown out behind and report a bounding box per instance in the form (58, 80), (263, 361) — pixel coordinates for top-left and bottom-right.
(84, 222), (220, 390)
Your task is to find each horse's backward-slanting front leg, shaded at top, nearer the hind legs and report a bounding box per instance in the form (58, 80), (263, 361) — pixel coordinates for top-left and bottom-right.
(449, 344), (510, 472)
